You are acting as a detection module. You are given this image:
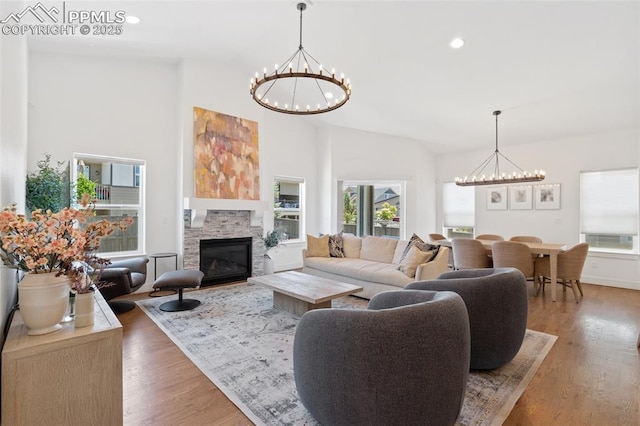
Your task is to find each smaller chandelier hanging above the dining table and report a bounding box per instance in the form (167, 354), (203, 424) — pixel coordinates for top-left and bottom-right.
(456, 111), (545, 186)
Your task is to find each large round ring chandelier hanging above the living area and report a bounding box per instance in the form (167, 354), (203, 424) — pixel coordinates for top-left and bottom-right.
(249, 3), (351, 115)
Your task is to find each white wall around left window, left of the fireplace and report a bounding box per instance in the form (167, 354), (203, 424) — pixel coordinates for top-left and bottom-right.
(28, 52), (182, 290)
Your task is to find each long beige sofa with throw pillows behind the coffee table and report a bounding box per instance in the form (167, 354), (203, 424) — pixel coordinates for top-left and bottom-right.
(302, 234), (449, 299)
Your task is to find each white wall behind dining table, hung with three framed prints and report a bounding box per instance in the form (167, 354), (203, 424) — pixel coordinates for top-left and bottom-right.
(438, 129), (640, 289)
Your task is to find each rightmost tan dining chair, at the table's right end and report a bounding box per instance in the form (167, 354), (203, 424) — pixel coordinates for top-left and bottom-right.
(535, 243), (589, 303)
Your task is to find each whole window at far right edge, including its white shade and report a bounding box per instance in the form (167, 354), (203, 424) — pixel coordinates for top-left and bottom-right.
(580, 169), (638, 253)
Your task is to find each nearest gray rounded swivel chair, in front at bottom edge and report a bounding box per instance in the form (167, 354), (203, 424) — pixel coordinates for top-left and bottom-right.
(293, 290), (470, 426)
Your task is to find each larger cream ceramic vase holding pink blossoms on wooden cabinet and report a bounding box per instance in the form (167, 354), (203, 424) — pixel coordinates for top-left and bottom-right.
(18, 272), (69, 336)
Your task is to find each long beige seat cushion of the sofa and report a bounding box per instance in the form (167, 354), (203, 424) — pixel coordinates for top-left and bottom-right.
(304, 257), (413, 287)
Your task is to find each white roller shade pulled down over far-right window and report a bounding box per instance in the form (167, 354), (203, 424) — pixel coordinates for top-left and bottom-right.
(580, 169), (639, 235)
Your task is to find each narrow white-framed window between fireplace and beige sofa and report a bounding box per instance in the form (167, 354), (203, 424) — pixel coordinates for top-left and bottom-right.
(273, 177), (305, 240)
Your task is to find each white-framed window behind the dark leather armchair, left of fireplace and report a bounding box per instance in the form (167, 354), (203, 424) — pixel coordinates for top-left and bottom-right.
(72, 153), (145, 258)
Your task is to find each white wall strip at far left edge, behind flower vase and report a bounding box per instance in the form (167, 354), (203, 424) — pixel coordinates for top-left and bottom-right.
(0, 17), (28, 342)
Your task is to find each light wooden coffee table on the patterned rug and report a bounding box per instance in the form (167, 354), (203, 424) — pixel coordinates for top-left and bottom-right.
(247, 271), (362, 316)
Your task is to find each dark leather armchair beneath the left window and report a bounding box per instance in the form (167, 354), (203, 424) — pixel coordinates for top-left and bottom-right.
(100, 257), (149, 314)
